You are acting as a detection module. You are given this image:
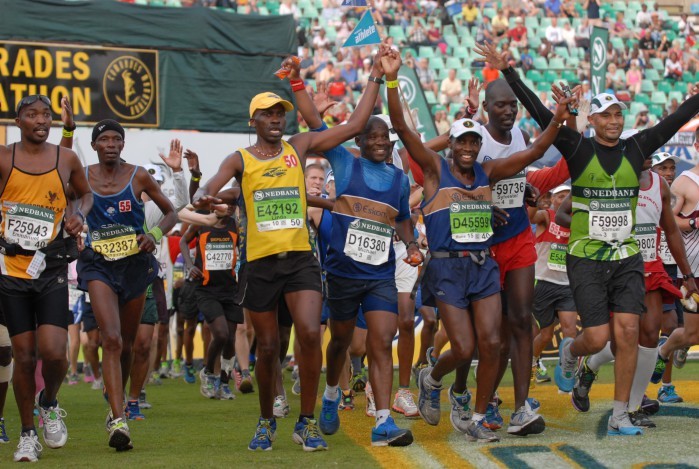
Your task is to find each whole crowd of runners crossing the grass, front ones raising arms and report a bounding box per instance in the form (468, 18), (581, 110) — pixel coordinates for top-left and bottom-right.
(0, 39), (699, 461)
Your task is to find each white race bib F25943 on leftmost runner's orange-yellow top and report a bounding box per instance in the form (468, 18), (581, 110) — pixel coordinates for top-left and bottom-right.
(4, 203), (56, 251)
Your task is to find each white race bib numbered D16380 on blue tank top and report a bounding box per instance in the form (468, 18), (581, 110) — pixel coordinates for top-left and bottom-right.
(344, 218), (393, 265)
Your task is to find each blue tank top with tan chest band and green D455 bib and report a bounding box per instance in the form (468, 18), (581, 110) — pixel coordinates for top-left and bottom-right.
(421, 159), (494, 252)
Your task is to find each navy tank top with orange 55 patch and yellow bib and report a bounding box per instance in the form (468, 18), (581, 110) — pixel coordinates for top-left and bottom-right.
(85, 166), (146, 260)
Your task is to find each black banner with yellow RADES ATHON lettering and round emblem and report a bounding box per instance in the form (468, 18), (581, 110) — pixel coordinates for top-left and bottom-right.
(0, 41), (160, 127)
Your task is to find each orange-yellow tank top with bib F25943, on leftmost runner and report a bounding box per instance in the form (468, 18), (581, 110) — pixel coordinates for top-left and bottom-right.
(0, 144), (66, 279)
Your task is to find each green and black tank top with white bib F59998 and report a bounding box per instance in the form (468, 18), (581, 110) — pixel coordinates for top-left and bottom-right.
(568, 154), (639, 261)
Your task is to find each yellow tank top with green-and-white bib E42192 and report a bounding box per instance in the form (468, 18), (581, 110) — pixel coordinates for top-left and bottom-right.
(238, 140), (311, 261)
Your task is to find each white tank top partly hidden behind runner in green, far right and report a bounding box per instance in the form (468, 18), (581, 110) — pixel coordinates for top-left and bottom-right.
(635, 171), (663, 262)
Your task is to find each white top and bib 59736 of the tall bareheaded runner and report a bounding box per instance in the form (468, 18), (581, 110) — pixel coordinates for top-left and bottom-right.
(476, 126), (527, 208)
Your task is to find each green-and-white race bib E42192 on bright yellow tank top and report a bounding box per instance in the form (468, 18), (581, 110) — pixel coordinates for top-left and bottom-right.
(253, 187), (306, 231)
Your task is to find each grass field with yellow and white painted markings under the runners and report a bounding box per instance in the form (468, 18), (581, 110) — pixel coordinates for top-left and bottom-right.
(0, 362), (699, 469)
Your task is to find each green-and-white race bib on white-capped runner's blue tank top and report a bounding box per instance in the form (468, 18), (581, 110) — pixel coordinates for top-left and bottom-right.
(449, 201), (493, 243)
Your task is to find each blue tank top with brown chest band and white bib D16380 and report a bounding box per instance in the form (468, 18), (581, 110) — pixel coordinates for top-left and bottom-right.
(325, 158), (403, 279)
